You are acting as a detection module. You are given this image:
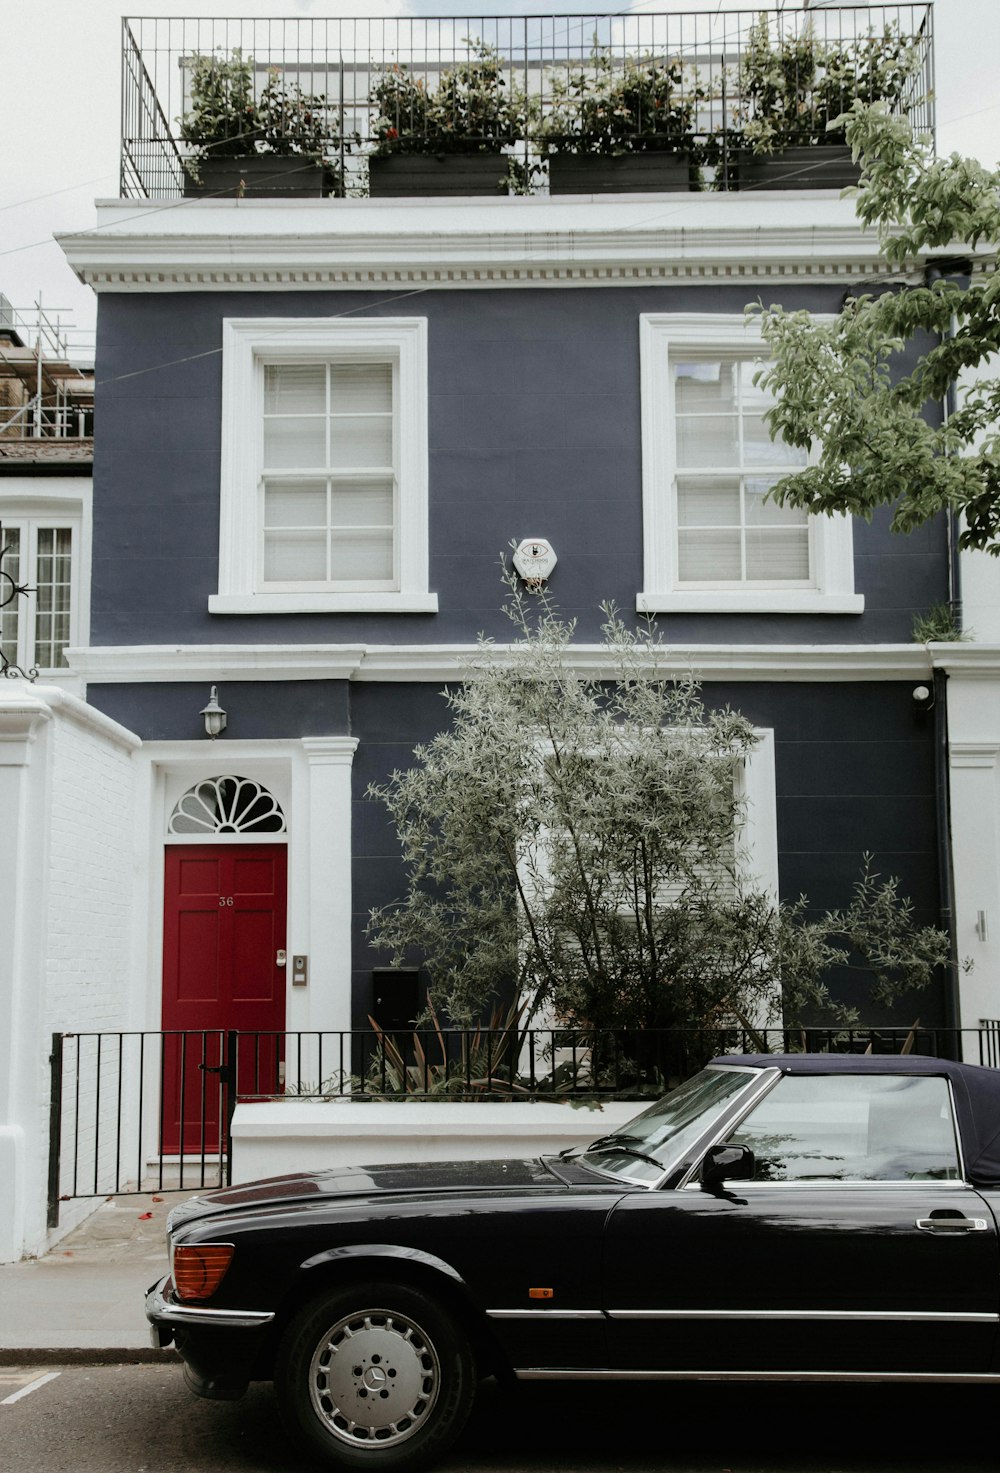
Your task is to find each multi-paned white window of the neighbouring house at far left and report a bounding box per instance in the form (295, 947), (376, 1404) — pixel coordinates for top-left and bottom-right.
(0, 502), (80, 670)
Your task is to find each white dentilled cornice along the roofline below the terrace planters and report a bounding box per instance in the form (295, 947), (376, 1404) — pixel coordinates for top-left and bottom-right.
(57, 190), (913, 292)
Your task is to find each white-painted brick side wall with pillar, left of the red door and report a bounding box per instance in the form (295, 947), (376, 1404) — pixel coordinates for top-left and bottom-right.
(0, 682), (143, 1261)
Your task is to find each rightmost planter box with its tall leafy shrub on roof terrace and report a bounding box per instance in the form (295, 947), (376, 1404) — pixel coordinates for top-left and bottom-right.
(727, 15), (919, 189)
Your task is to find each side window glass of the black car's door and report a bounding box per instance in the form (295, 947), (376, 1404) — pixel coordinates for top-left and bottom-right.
(729, 1074), (960, 1181)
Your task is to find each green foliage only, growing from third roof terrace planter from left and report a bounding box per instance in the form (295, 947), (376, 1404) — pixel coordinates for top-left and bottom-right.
(539, 46), (704, 155)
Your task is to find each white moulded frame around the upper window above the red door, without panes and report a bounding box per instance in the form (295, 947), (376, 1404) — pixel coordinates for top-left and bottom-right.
(208, 317), (437, 614)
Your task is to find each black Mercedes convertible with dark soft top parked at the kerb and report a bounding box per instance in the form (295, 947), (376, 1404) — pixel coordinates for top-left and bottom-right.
(146, 1055), (1000, 1469)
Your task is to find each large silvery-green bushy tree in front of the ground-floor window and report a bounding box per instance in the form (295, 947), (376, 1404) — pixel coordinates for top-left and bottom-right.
(370, 582), (947, 1028)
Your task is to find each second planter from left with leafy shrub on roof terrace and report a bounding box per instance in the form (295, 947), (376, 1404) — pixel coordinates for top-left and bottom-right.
(368, 41), (526, 196)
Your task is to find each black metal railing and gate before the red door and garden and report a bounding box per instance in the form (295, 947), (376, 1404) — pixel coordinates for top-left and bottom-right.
(49, 1024), (1000, 1226)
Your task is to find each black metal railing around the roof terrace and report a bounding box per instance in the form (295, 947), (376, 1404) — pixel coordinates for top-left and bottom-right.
(121, 4), (934, 199)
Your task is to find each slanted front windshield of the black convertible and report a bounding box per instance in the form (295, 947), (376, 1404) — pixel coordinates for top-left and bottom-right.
(583, 1066), (760, 1181)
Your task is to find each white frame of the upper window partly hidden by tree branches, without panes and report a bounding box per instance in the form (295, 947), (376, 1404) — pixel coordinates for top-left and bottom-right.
(636, 312), (865, 614)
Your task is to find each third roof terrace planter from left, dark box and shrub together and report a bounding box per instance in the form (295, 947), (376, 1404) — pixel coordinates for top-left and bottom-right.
(539, 47), (704, 194)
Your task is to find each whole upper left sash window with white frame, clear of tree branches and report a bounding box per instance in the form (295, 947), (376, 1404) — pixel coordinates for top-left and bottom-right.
(209, 318), (437, 614)
